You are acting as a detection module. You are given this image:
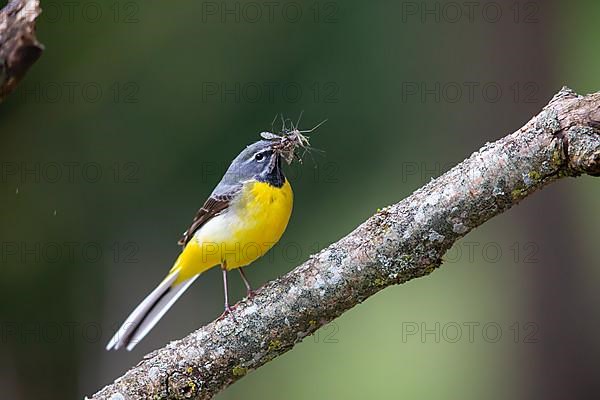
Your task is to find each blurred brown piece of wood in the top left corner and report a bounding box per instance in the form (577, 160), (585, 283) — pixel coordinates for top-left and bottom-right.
(0, 0), (44, 102)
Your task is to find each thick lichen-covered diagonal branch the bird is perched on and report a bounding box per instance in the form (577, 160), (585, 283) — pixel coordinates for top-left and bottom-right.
(93, 88), (600, 400)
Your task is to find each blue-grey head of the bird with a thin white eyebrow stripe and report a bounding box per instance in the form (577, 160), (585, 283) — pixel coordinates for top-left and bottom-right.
(223, 140), (285, 187)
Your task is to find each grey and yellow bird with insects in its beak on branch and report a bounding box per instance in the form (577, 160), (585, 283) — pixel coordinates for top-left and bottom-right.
(106, 135), (300, 350)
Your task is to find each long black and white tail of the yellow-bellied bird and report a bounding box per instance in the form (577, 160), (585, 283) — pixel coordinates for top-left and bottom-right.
(106, 269), (198, 350)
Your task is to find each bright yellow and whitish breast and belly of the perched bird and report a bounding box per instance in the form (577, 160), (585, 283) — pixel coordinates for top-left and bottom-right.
(173, 180), (293, 282)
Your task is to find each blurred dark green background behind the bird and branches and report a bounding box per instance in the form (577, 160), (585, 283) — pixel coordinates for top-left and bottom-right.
(0, 0), (600, 400)
